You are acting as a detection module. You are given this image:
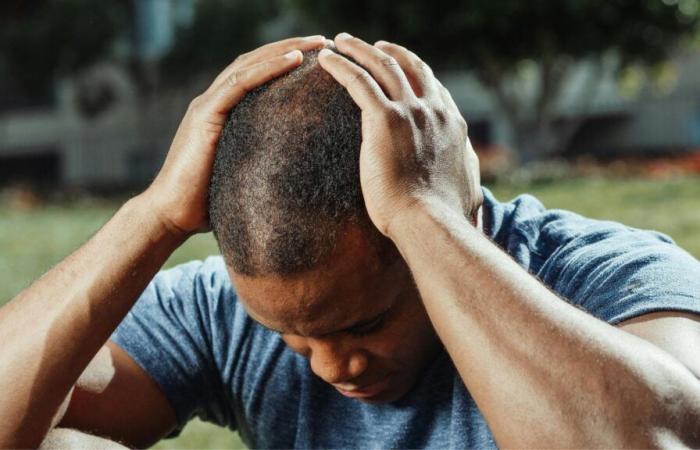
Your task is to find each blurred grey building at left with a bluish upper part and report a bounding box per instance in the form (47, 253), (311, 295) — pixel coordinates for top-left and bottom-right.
(0, 0), (196, 188)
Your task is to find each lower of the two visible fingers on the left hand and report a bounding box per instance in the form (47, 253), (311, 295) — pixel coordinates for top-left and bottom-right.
(205, 50), (304, 120)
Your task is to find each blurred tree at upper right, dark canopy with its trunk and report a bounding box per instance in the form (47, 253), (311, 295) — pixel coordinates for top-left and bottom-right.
(289, 0), (700, 160)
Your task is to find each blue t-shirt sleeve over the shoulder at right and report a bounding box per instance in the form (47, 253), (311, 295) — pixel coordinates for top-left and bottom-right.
(484, 189), (700, 323)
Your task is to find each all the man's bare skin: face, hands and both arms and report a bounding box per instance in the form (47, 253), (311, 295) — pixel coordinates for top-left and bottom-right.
(0, 31), (700, 448)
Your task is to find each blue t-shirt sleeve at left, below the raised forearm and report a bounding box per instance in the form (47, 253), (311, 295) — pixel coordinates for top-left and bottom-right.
(111, 258), (235, 436)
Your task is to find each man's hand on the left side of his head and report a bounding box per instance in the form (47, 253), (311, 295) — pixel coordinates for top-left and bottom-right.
(143, 36), (324, 236)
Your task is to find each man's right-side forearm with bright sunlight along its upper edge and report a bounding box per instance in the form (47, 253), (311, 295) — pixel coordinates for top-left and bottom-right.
(391, 200), (698, 447)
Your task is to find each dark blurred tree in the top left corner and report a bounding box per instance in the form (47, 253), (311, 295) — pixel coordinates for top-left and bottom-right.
(0, 0), (127, 109)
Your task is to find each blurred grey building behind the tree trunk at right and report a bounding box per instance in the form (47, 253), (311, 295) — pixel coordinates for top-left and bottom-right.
(445, 52), (700, 157)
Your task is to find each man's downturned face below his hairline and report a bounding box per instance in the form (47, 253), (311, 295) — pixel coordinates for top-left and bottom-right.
(230, 226), (440, 403)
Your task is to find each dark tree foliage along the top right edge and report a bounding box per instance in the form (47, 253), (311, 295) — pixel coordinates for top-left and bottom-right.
(290, 0), (699, 71)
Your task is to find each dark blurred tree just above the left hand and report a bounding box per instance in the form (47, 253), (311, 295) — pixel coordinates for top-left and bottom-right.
(159, 0), (278, 84)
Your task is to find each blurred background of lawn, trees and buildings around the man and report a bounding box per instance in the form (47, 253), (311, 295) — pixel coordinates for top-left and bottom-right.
(0, 0), (700, 448)
